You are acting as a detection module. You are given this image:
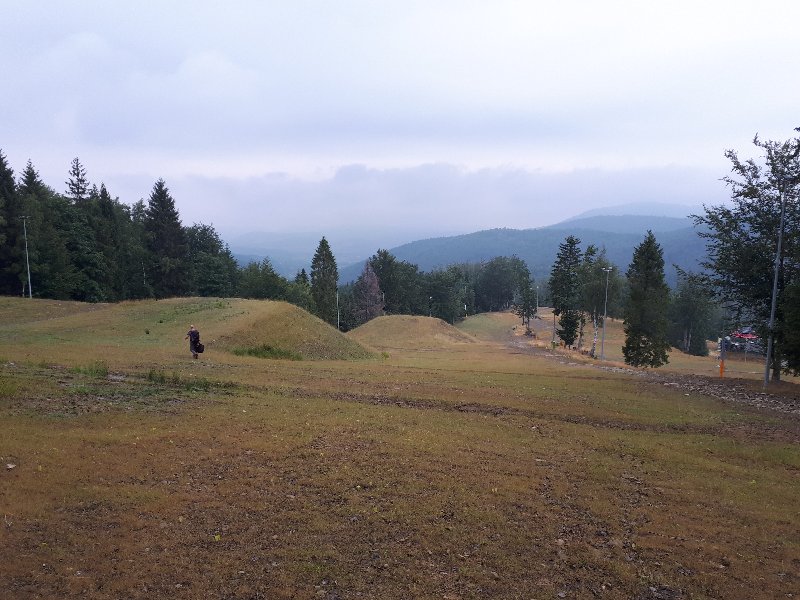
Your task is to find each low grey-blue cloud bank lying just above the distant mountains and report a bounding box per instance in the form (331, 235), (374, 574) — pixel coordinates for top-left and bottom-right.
(159, 164), (728, 244)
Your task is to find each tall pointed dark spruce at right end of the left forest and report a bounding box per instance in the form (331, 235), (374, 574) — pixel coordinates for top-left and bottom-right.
(144, 179), (189, 298)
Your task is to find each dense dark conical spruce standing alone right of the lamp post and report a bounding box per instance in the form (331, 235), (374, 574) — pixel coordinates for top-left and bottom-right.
(622, 231), (669, 367)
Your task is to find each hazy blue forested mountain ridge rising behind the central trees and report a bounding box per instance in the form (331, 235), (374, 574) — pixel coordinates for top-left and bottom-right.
(230, 203), (705, 283)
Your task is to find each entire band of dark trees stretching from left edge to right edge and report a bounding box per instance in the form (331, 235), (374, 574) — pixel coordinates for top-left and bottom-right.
(0, 128), (800, 379)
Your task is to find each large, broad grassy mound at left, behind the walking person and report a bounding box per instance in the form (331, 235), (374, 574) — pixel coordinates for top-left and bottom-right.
(0, 298), (373, 368)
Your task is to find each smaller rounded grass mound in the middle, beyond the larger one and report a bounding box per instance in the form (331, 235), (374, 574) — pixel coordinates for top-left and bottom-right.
(347, 315), (475, 350)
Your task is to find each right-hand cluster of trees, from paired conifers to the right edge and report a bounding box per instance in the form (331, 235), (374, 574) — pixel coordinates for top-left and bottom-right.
(549, 128), (800, 384)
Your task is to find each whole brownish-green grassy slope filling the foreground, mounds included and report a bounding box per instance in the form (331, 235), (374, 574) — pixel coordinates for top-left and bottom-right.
(0, 298), (800, 600)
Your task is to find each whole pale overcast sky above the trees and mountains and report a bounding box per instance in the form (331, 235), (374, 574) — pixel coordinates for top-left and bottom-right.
(0, 0), (800, 246)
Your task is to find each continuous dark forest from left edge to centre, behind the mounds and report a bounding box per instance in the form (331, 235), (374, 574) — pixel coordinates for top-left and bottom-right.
(0, 151), (532, 330)
